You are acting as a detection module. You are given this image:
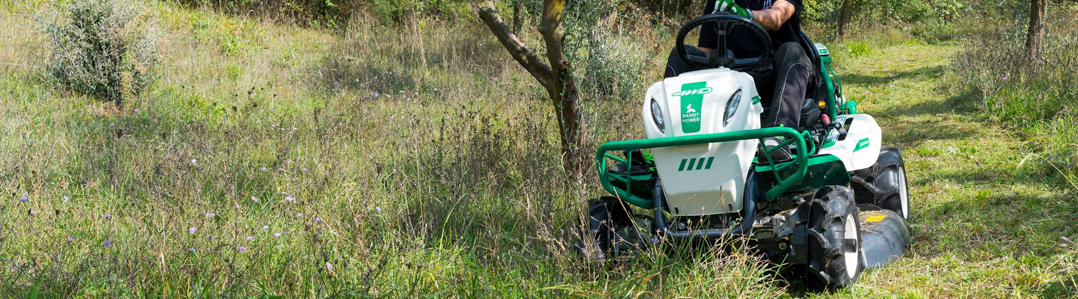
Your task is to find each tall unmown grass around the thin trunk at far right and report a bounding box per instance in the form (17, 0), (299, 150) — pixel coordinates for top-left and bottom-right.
(953, 4), (1078, 152)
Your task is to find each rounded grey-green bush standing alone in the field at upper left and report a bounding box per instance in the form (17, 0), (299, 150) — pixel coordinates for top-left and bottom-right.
(42, 0), (157, 106)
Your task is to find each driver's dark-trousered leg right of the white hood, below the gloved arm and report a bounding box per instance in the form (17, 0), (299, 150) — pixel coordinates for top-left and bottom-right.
(761, 42), (816, 128)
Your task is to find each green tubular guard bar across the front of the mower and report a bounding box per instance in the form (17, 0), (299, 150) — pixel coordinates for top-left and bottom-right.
(595, 126), (816, 208)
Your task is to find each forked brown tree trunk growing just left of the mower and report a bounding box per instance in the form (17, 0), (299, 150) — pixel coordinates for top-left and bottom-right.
(479, 0), (586, 175)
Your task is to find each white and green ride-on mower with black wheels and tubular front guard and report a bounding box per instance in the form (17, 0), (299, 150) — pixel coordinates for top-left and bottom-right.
(578, 13), (911, 288)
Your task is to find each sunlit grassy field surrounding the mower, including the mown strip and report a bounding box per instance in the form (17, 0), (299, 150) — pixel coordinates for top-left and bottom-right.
(0, 1), (1078, 298)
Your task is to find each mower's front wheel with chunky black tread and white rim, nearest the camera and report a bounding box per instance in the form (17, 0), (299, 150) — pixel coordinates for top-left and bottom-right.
(806, 186), (863, 288)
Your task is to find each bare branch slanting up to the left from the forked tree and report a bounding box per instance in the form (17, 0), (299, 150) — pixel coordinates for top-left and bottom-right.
(479, 1), (555, 90)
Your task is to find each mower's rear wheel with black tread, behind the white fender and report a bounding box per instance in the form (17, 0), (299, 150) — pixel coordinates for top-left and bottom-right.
(849, 148), (910, 221)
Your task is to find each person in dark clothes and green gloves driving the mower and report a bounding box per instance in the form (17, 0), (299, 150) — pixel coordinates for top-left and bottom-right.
(665, 0), (816, 161)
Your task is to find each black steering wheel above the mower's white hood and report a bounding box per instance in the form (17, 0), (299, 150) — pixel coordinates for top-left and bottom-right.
(675, 12), (772, 70)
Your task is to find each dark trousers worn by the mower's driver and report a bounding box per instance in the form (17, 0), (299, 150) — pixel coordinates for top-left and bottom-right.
(665, 42), (816, 130)
